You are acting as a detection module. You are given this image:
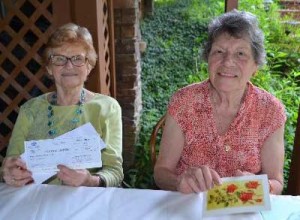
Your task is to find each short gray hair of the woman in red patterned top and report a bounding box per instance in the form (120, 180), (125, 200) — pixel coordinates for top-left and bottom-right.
(202, 9), (266, 67)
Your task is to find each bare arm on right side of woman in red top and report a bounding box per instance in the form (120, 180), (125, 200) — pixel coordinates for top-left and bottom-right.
(261, 125), (284, 195)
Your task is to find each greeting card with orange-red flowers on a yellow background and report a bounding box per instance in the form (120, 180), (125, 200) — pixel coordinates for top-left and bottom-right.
(203, 175), (271, 216)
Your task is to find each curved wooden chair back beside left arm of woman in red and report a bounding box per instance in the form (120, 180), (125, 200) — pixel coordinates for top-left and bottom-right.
(149, 114), (166, 168)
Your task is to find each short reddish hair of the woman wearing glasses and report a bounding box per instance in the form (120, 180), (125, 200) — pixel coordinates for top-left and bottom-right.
(43, 23), (97, 68)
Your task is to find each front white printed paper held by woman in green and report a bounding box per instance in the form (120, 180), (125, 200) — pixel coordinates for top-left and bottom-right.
(25, 136), (102, 172)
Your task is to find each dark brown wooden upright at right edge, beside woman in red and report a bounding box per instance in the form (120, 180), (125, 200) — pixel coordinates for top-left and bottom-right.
(286, 106), (300, 196)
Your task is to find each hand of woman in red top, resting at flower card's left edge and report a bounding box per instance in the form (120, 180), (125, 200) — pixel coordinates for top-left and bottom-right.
(177, 166), (221, 194)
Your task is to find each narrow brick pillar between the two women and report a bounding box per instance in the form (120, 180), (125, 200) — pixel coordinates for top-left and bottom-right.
(114, 0), (142, 170)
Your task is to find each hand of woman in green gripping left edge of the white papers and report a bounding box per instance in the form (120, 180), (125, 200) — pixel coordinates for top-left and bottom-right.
(2, 156), (33, 187)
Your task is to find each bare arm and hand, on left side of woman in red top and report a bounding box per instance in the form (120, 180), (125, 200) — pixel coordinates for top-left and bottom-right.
(154, 114), (221, 193)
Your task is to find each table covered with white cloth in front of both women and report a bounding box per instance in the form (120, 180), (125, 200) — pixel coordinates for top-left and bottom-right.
(0, 183), (300, 220)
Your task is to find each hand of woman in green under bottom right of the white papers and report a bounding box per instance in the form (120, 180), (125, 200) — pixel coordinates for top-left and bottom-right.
(57, 165), (99, 186)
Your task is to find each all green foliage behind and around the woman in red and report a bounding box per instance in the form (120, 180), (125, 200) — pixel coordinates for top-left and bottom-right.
(125, 0), (300, 188)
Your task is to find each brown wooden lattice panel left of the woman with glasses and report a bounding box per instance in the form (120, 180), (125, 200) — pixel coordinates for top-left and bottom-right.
(0, 0), (54, 153)
